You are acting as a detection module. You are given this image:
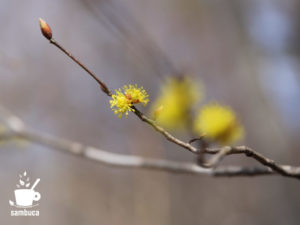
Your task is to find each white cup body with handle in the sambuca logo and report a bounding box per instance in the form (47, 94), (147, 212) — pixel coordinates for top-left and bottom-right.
(15, 189), (41, 206)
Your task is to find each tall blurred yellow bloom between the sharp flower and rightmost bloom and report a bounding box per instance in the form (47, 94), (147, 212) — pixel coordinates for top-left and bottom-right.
(151, 77), (202, 130)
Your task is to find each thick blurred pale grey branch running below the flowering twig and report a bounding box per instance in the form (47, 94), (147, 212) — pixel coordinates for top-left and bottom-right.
(0, 123), (274, 177)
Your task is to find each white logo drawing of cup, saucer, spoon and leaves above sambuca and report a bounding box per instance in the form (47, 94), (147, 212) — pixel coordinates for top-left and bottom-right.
(9, 171), (41, 208)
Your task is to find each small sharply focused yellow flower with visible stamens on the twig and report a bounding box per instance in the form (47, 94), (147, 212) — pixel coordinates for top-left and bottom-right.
(109, 84), (149, 118)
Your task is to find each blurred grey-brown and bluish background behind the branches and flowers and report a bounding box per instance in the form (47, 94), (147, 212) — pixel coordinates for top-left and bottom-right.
(0, 0), (300, 225)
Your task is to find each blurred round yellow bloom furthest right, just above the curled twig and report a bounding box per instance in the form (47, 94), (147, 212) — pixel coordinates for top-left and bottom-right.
(195, 103), (244, 144)
